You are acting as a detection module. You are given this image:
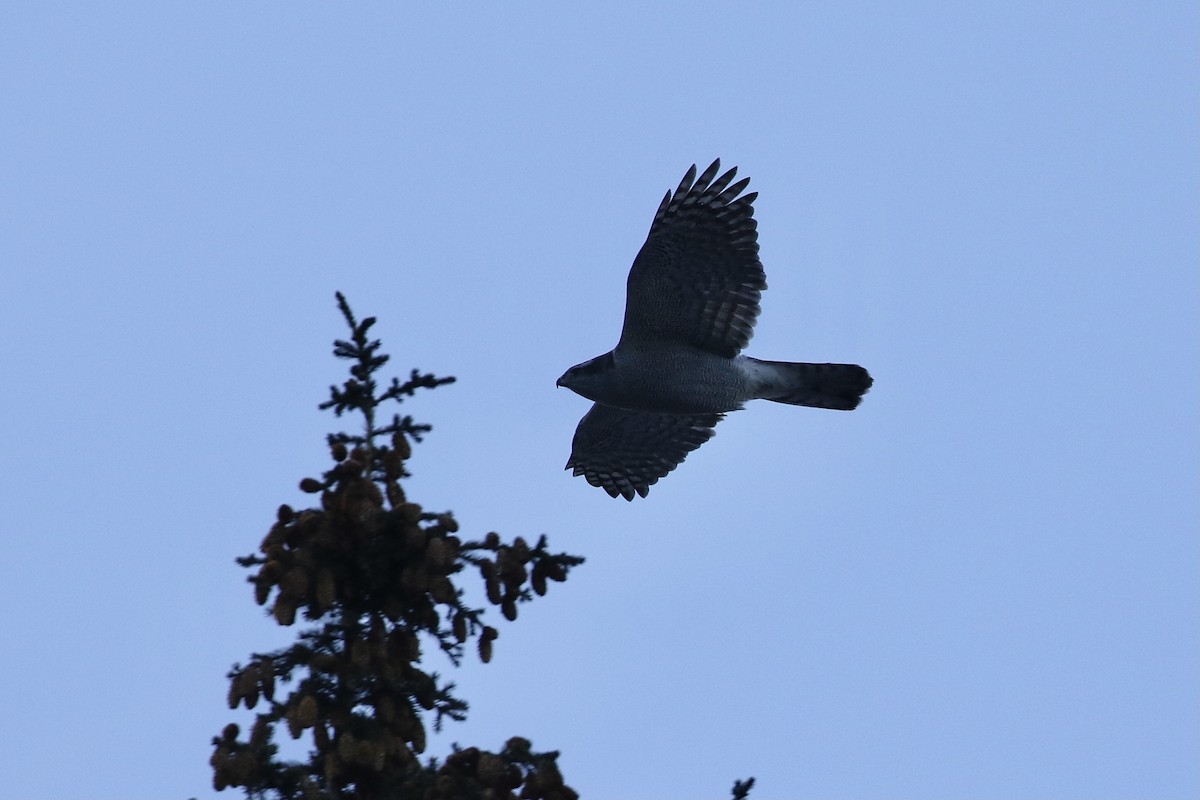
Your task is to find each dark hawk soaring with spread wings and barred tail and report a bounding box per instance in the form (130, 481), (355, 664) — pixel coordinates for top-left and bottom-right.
(558, 160), (872, 500)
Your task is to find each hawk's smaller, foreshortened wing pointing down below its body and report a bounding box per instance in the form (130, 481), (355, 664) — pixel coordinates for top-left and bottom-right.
(566, 403), (722, 500)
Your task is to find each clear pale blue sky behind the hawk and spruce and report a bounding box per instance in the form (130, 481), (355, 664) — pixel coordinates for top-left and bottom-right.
(0, 0), (1200, 800)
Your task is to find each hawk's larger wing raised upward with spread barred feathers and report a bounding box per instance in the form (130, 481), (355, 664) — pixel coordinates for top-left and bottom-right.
(617, 160), (767, 357)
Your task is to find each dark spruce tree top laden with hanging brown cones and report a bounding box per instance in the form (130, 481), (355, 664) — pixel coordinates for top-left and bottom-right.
(210, 294), (583, 800)
